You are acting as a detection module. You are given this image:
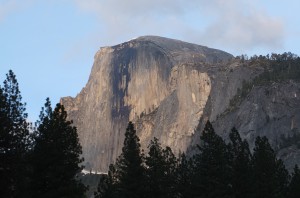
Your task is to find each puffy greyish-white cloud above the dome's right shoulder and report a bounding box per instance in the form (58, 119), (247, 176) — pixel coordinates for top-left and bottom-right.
(196, 0), (284, 50)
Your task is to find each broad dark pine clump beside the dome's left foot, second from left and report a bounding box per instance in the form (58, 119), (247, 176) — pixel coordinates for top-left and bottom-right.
(32, 98), (86, 198)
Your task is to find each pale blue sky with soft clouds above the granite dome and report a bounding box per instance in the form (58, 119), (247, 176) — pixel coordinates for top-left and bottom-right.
(0, 0), (300, 122)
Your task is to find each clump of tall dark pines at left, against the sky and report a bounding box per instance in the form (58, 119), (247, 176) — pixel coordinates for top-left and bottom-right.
(0, 70), (87, 198)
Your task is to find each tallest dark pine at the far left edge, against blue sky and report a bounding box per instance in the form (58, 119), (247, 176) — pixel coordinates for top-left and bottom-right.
(0, 70), (29, 198)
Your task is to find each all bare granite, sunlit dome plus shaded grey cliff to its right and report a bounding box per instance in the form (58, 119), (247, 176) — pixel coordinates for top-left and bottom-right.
(61, 36), (300, 171)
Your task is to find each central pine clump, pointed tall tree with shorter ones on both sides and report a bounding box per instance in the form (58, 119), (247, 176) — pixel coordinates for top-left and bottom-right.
(95, 125), (177, 198)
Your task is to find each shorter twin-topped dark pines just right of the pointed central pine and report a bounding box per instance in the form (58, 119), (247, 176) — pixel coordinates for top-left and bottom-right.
(146, 138), (177, 198)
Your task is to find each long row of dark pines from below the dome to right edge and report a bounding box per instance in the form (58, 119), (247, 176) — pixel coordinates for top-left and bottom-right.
(95, 121), (300, 198)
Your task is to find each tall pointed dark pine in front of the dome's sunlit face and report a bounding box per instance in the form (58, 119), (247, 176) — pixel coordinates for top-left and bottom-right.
(115, 122), (145, 198)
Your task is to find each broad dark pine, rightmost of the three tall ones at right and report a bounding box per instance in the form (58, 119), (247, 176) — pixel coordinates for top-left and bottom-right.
(252, 137), (288, 198)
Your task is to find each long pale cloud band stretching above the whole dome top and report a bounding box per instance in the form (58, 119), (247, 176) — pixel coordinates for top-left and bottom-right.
(75, 0), (285, 54)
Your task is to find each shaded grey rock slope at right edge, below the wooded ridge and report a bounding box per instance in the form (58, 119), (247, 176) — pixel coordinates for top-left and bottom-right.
(213, 81), (300, 170)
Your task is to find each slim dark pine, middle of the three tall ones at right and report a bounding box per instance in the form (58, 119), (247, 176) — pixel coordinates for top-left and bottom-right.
(228, 128), (253, 198)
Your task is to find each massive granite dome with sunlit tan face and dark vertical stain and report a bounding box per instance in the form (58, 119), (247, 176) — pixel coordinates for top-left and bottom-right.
(61, 36), (232, 171)
